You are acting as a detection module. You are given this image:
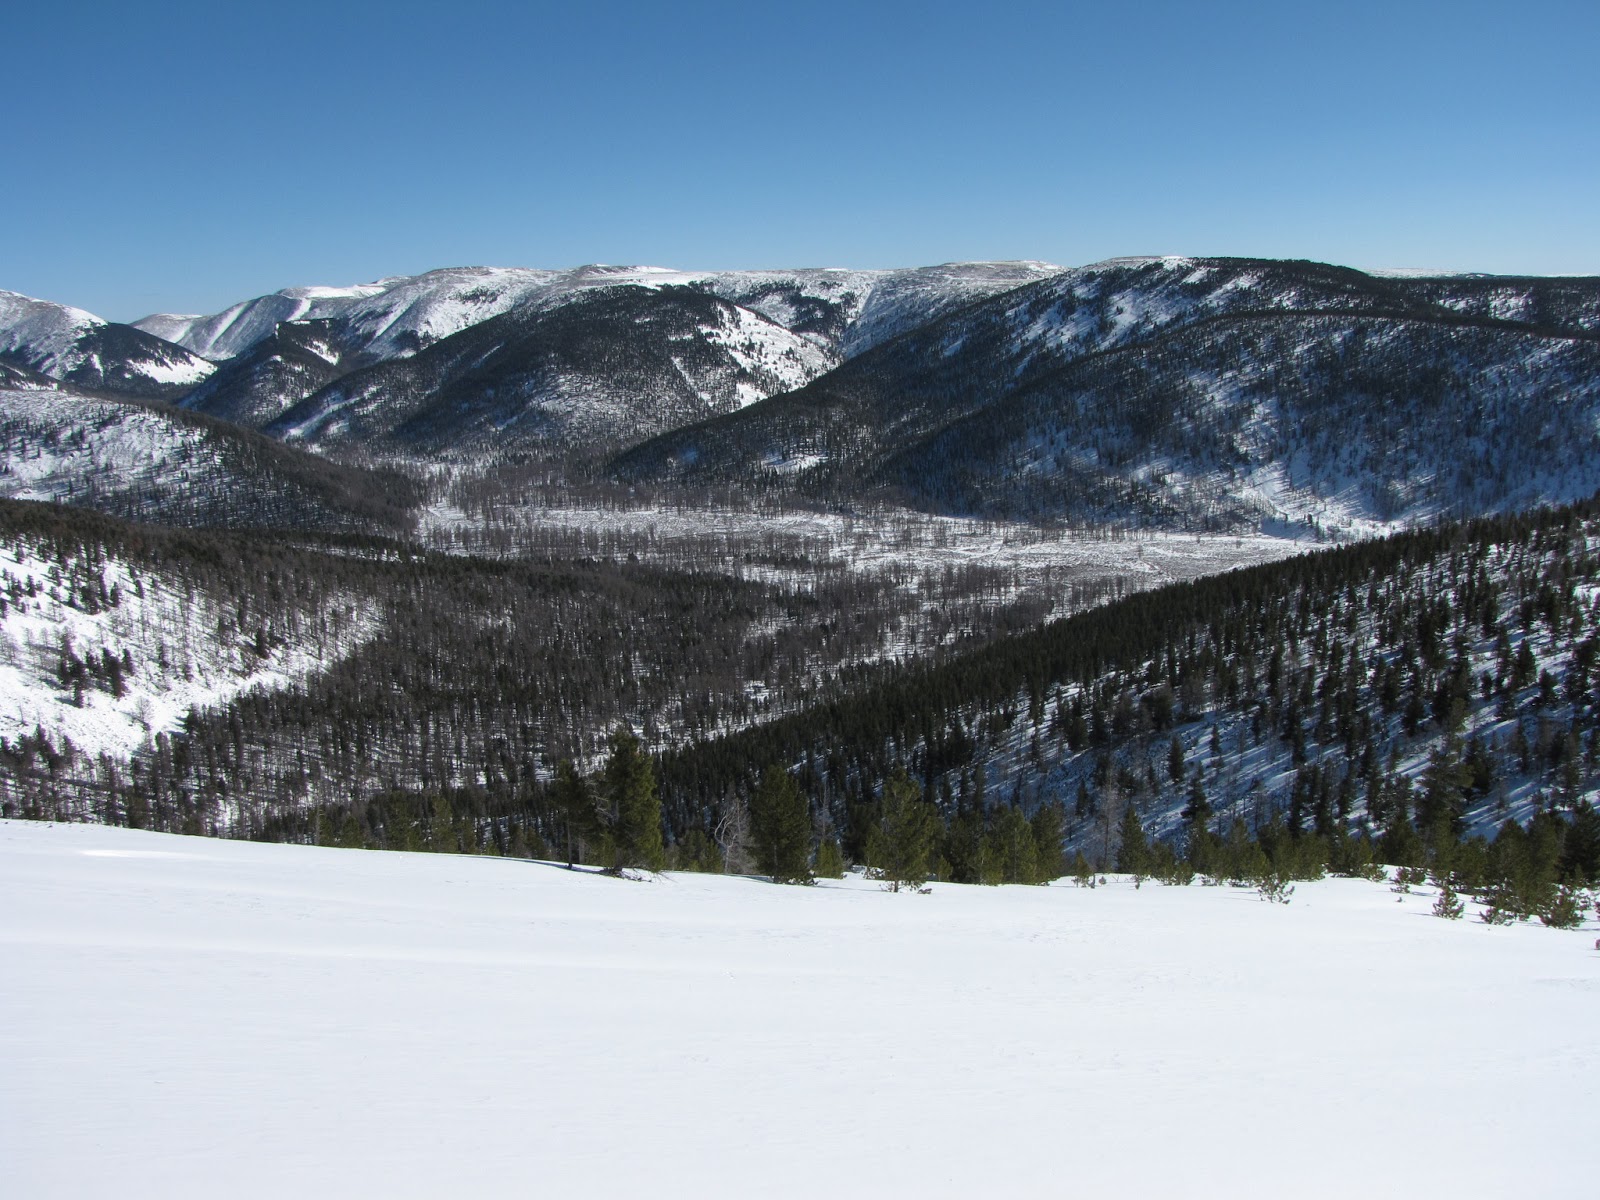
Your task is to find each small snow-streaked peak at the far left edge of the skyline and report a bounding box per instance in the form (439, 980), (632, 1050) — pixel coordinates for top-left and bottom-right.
(0, 291), (216, 398)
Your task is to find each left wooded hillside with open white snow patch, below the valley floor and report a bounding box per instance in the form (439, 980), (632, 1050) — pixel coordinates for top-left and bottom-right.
(0, 504), (1068, 834)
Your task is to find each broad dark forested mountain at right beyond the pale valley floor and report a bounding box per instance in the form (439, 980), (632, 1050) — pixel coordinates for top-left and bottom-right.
(614, 259), (1600, 526)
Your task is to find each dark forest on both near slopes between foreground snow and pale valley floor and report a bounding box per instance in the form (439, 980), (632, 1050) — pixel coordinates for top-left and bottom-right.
(0, 501), (1600, 912)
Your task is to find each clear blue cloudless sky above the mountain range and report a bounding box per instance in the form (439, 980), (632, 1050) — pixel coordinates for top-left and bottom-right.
(0, 0), (1600, 320)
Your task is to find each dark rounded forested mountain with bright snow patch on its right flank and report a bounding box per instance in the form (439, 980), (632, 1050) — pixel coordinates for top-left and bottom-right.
(267, 286), (827, 454)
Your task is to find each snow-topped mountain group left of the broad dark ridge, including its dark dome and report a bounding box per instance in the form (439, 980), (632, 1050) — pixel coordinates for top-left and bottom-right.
(136, 262), (1058, 453)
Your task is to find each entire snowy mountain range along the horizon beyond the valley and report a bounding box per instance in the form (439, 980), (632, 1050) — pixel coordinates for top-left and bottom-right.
(12, 256), (1600, 534)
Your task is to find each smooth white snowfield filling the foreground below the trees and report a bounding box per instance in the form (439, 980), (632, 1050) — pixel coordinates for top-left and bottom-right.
(0, 822), (1600, 1198)
